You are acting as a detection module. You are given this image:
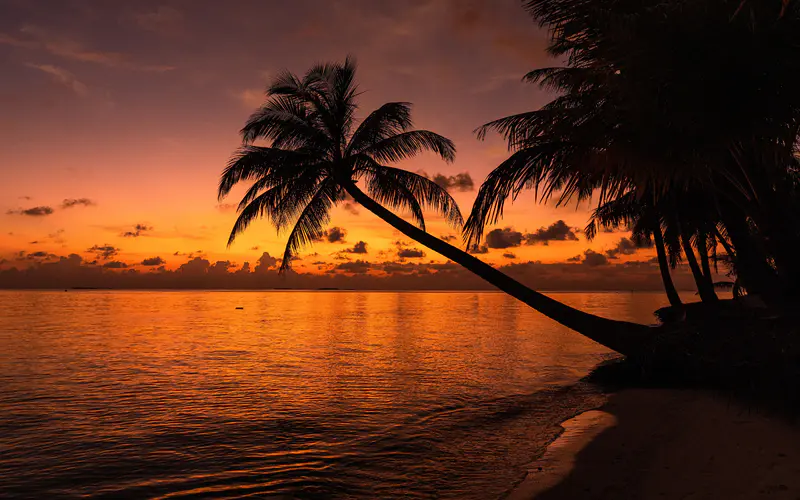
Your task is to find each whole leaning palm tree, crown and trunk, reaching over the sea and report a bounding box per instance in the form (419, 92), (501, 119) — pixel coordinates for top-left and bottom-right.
(219, 58), (649, 354)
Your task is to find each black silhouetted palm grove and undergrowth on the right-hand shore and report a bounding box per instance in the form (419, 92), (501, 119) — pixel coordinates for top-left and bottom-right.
(465, 0), (800, 390)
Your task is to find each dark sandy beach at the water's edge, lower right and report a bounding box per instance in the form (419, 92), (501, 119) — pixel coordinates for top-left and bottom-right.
(509, 389), (800, 500)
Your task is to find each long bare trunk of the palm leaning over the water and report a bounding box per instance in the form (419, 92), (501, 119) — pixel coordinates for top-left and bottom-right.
(341, 180), (652, 355)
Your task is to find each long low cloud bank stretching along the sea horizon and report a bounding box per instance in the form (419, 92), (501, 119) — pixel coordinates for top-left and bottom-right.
(0, 252), (694, 291)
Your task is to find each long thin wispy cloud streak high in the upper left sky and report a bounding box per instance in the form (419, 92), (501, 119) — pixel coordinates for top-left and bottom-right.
(10, 25), (174, 72)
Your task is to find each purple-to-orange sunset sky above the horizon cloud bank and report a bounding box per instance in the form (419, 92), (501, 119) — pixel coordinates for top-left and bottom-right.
(0, 0), (688, 288)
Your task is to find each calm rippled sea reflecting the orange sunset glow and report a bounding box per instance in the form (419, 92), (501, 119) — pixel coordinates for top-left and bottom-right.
(0, 291), (684, 499)
